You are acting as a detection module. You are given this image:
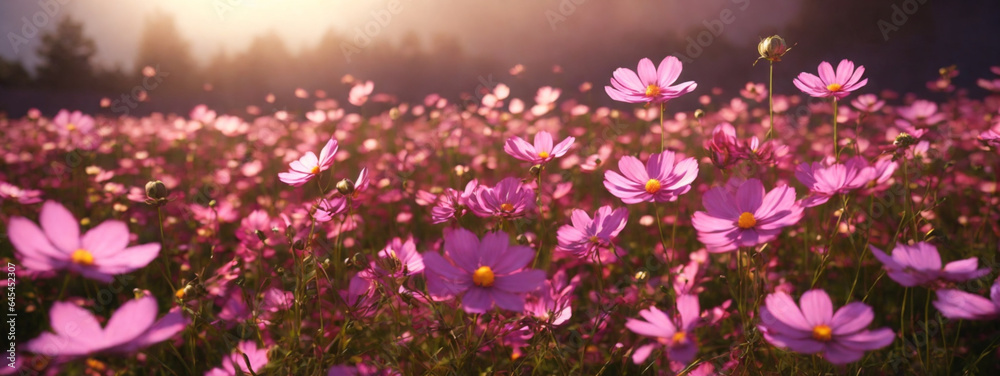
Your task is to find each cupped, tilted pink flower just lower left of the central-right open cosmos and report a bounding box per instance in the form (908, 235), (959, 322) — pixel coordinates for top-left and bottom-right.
(556, 205), (628, 260)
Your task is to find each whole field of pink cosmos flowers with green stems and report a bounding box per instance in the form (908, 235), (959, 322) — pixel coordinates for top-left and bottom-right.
(0, 43), (1000, 376)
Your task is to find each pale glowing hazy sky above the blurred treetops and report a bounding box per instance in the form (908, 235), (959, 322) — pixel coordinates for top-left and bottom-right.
(0, 0), (797, 68)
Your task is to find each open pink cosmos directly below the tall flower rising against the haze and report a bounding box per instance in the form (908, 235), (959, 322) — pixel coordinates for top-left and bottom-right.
(604, 151), (698, 204)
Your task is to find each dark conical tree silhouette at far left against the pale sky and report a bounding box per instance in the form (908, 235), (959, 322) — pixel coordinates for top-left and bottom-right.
(38, 17), (97, 89)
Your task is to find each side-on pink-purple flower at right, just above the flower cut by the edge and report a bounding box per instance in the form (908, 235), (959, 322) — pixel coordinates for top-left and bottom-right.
(869, 242), (990, 287)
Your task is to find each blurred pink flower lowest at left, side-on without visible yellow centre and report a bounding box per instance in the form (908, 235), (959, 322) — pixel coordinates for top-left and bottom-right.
(25, 296), (188, 358)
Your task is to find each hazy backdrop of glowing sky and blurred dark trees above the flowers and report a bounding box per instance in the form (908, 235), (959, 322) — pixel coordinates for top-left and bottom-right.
(0, 0), (1000, 116)
